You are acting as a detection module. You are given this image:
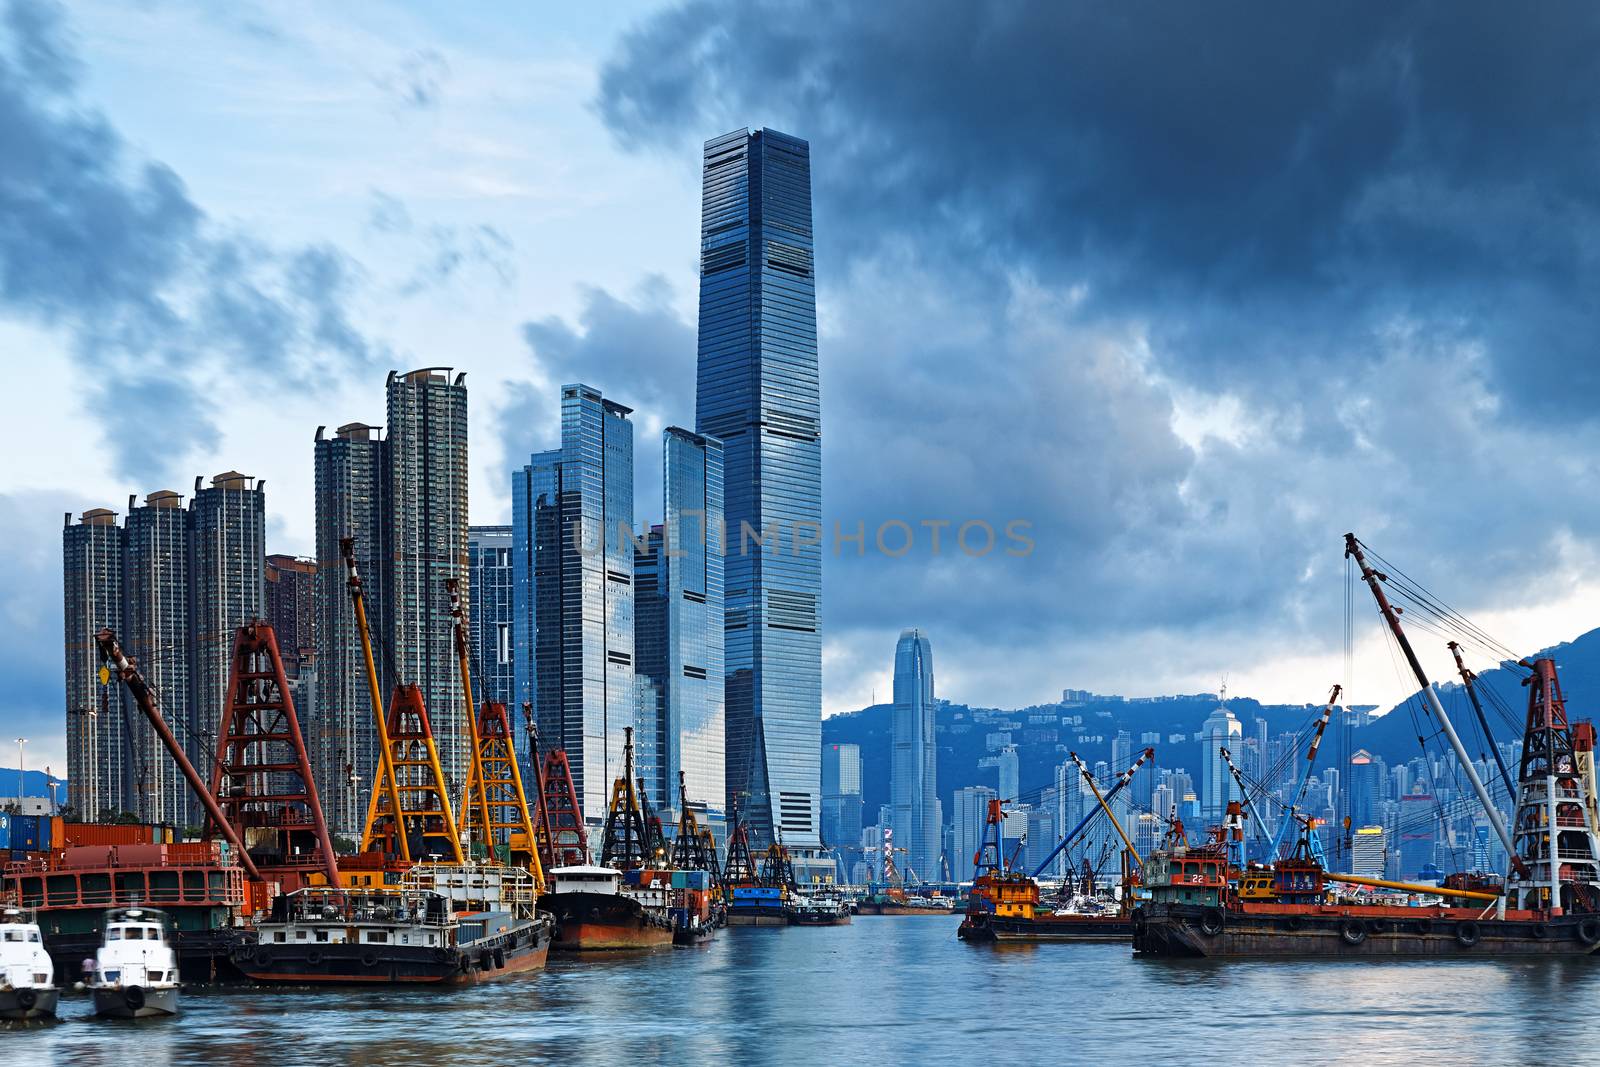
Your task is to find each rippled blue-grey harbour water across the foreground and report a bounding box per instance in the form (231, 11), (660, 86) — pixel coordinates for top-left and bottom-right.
(12, 917), (1600, 1067)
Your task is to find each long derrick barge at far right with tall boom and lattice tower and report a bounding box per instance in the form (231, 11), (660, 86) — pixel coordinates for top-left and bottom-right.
(1133, 534), (1600, 958)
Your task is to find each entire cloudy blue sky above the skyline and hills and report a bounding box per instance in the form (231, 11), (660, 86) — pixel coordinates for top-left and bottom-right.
(0, 0), (1600, 771)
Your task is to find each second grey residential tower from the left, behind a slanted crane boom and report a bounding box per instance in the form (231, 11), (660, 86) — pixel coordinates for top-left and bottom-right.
(120, 490), (198, 824)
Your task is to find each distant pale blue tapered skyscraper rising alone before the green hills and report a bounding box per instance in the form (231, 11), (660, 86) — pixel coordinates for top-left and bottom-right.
(890, 630), (939, 878)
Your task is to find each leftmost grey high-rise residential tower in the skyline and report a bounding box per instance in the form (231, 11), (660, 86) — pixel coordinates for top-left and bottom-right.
(61, 507), (131, 821)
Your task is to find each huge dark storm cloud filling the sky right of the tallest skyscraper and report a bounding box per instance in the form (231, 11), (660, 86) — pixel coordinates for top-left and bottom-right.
(597, 2), (1600, 700)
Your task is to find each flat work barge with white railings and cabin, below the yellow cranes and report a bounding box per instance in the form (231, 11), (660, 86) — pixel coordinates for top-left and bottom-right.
(234, 864), (552, 985)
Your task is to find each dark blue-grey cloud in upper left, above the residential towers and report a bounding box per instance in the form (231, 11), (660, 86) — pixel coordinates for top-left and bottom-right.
(0, 0), (379, 483)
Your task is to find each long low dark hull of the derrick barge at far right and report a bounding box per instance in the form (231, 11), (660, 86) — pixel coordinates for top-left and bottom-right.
(1133, 904), (1600, 960)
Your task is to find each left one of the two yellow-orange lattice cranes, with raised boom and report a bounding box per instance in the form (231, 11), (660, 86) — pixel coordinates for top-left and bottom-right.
(339, 537), (462, 865)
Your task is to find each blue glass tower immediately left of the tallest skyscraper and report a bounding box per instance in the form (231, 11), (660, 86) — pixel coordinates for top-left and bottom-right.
(634, 426), (726, 840)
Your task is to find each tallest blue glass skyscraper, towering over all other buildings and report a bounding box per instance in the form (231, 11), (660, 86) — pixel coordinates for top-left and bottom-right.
(694, 130), (822, 848)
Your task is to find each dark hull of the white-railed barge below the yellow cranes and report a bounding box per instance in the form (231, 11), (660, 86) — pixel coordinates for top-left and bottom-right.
(234, 921), (552, 985)
